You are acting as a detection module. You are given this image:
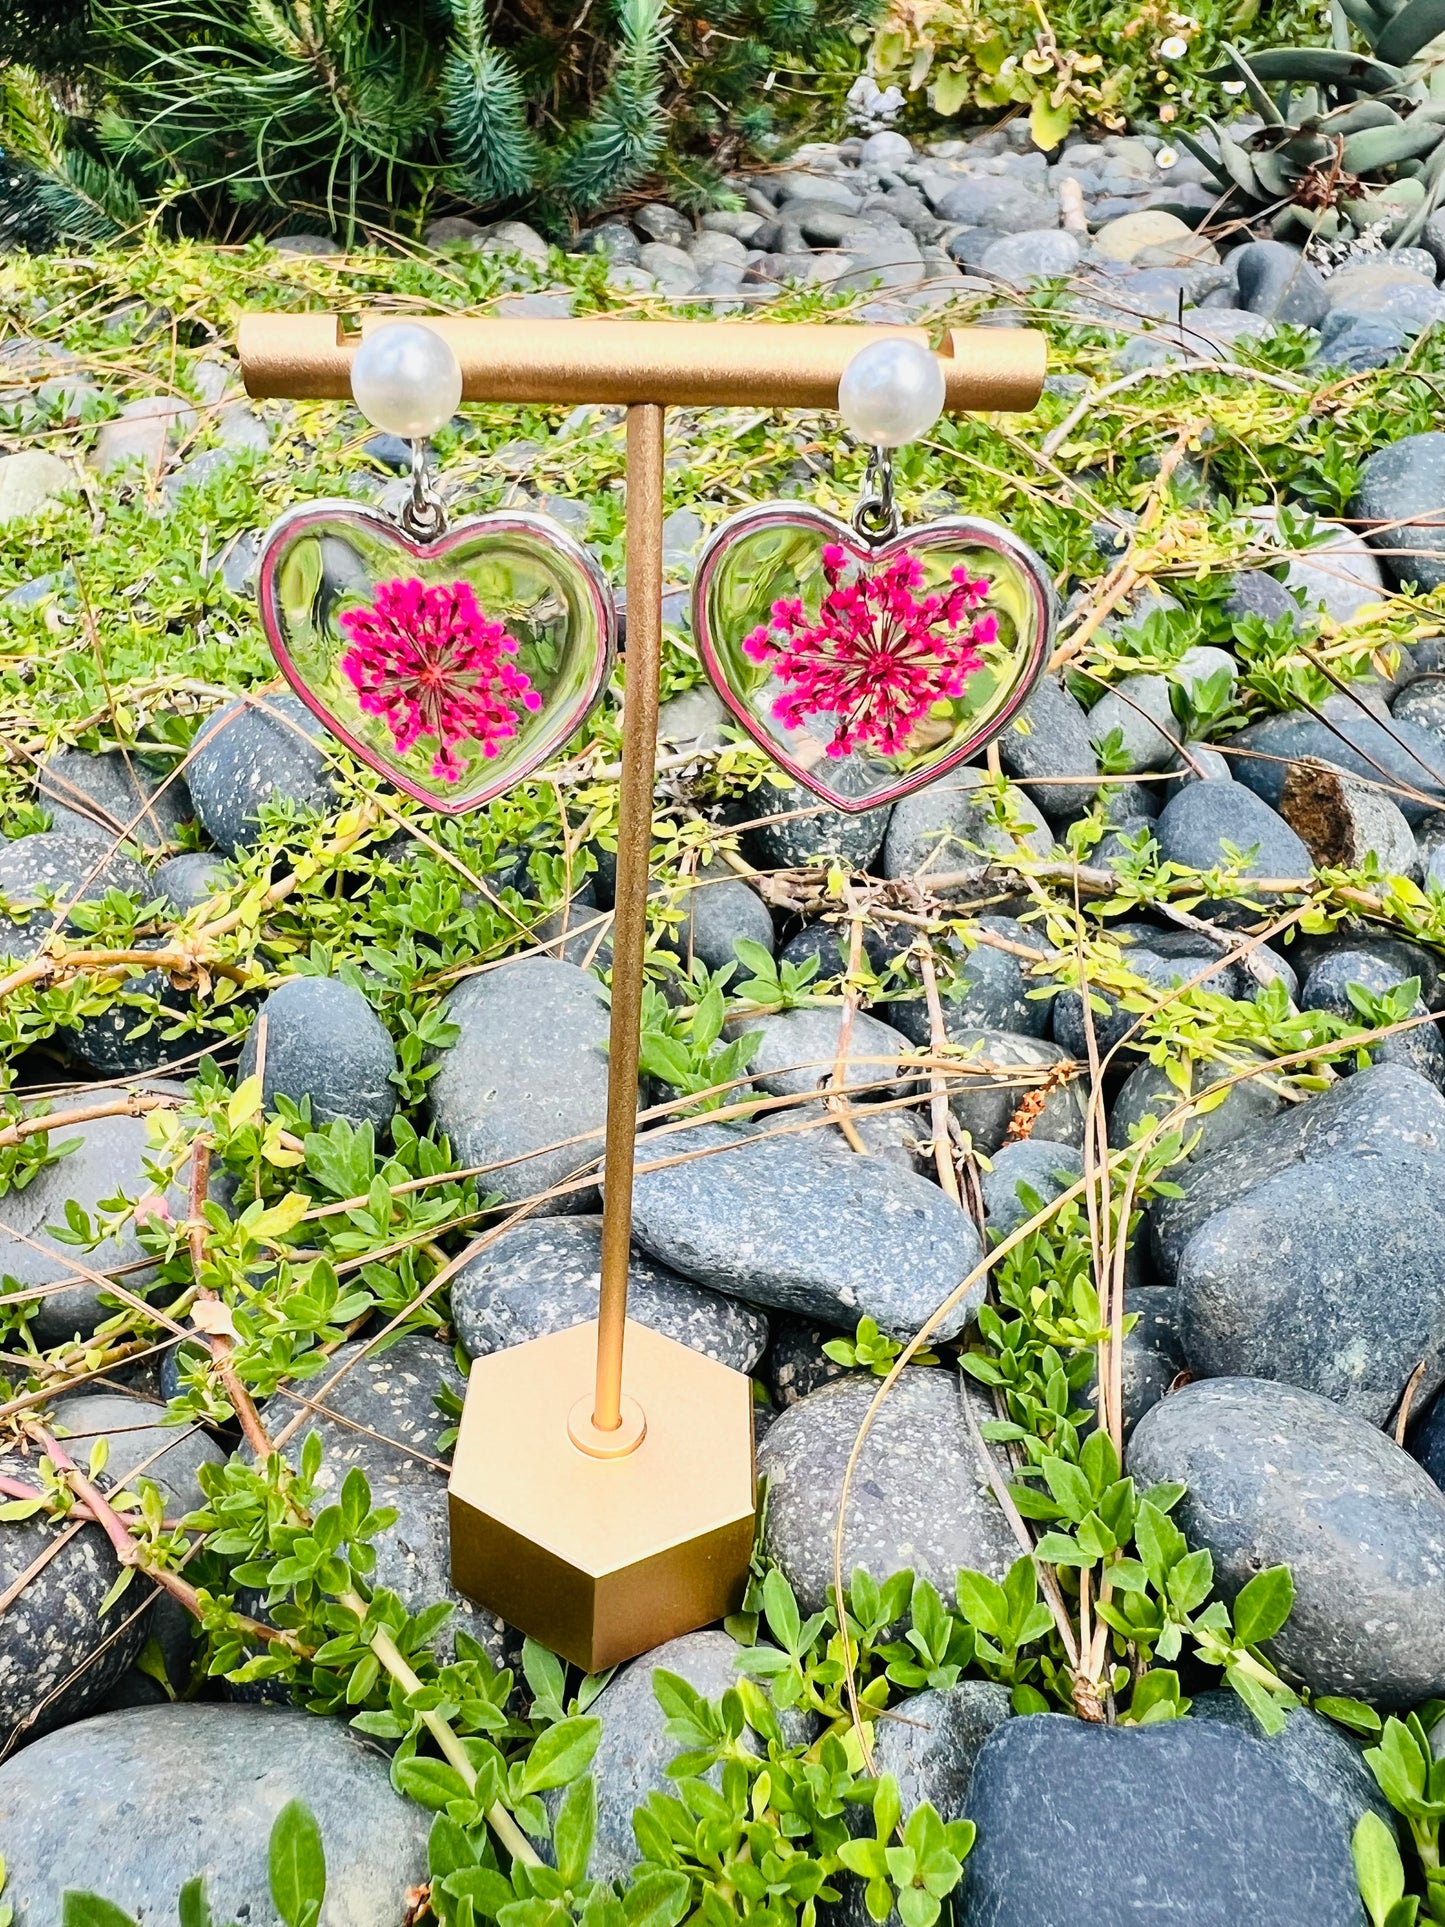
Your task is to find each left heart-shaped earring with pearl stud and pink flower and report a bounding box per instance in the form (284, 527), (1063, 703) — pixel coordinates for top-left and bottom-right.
(256, 322), (617, 815)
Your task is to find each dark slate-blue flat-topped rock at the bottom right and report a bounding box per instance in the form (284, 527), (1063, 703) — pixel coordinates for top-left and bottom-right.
(959, 1713), (1362, 1927)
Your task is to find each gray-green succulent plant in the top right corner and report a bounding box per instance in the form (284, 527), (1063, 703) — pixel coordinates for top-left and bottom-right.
(1175, 0), (1445, 247)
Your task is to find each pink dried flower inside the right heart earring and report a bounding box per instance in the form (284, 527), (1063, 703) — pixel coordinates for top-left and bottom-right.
(742, 543), (998, 755)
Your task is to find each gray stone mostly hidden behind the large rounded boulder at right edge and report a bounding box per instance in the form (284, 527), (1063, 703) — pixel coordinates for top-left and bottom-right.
(1148, 1064), (1445, 1283)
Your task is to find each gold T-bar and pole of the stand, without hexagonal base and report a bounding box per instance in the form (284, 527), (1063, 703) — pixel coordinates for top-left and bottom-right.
(239, 310), (1046, 1457)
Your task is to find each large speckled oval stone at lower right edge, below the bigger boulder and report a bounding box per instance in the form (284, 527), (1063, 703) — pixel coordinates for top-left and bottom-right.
(1129, 1378), (1445, 1707)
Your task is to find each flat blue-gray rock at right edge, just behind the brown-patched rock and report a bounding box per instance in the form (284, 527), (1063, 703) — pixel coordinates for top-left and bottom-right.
(1229, 694), (1445, 823)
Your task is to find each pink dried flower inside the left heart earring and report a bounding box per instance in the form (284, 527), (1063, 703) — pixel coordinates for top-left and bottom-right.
(341, 578), (541, 782)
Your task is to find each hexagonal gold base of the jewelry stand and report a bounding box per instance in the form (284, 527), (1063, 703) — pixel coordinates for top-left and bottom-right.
(449, 1320), (755, 1673)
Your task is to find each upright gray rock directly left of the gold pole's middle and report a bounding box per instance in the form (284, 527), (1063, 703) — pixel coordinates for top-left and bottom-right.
(428, 958), (609, 1212)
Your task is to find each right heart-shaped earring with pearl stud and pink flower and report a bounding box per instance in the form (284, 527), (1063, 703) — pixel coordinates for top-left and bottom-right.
(692, 335), (1054, 811)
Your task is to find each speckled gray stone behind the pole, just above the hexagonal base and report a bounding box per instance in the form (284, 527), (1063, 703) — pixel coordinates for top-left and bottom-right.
(451, 1218), (767, 1372)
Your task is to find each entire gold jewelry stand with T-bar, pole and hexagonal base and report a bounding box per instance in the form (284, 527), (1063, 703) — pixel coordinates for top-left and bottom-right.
(239, 312), (1044, 1673)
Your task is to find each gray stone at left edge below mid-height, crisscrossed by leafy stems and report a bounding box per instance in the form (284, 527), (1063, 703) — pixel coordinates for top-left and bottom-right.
(0, 1083), (187, 1345)
